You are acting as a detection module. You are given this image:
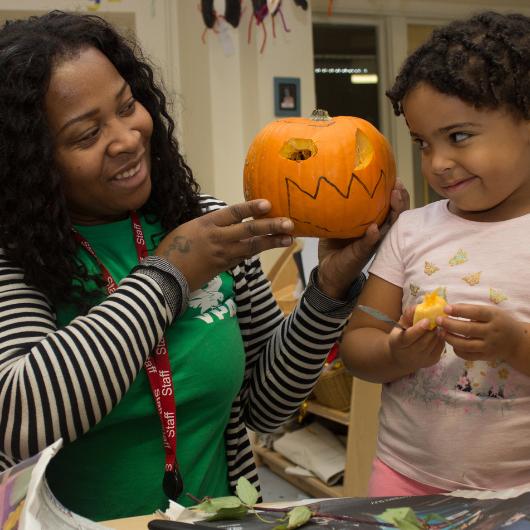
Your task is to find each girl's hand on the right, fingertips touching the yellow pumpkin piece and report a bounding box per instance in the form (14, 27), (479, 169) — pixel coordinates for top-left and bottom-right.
(436, 304), (530, 373)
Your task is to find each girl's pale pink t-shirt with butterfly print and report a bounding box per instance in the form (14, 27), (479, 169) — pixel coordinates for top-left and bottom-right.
(370, 200), (530, 490)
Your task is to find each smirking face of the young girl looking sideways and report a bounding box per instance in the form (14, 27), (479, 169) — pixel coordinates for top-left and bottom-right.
(403, 83), (530, 221)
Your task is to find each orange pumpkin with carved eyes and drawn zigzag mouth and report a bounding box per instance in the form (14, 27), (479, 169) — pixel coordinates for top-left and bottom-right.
(244, 110), (396, 238)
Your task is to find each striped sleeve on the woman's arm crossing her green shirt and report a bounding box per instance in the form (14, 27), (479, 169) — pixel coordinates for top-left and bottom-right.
(0, 253), (180, 469)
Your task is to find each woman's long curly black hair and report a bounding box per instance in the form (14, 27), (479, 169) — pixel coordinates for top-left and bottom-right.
(0, 11), (201, 304)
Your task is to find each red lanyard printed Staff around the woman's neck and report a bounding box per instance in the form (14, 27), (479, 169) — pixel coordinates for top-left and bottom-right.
(74, 208), (184, 500)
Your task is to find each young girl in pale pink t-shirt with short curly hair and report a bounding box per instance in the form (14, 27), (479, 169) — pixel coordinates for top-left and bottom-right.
(341, 12), (530, 496)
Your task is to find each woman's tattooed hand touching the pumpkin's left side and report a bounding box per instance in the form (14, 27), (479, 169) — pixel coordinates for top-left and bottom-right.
(155, 199), (294, 291)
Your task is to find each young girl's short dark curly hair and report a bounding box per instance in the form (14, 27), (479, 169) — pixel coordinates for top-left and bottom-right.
(386, 11), (530, 120)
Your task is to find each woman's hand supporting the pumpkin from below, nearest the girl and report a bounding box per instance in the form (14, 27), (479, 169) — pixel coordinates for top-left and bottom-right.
(318, 180), (410, 300)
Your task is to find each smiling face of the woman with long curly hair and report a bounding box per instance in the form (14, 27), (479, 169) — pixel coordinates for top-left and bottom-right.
(45, 48), (153, 224)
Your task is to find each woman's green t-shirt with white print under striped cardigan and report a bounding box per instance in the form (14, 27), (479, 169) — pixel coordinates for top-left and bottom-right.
(47, 217), (245, 521)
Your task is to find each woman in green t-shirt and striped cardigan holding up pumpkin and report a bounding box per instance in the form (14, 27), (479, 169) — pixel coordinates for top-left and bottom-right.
(0, 12), (407, 520)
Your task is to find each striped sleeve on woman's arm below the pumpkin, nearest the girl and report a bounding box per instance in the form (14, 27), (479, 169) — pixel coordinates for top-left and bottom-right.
(197, 196), (358, 438)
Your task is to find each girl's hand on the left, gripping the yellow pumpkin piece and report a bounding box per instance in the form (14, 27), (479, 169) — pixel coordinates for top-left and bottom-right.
(388, 306), (445, 373)
